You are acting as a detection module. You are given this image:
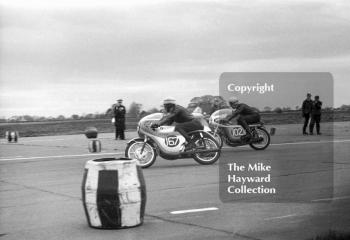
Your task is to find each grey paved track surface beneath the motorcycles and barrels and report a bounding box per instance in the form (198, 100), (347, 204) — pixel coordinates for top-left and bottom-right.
(0, 123), (350, 240)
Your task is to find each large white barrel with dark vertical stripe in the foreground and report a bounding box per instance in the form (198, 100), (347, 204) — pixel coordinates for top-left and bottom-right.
(82, 158), (146, 229)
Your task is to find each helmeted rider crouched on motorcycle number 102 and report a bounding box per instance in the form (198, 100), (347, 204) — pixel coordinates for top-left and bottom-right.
(226, 96), (260, 141)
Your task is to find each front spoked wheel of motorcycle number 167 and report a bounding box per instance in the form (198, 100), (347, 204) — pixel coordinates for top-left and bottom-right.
(125, 141), (157, 168)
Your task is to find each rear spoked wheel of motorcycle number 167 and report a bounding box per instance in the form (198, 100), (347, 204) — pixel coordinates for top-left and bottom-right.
(193, 137), (220, 165)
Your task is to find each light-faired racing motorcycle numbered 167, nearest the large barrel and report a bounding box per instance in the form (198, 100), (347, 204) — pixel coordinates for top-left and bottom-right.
(125, 113), (221, 168)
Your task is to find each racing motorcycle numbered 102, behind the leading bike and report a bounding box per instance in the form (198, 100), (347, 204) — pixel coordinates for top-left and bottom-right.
(209, 109), (271, 150)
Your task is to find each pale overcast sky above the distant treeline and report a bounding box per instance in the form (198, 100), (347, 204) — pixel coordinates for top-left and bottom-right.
(0, 0), (350, 117)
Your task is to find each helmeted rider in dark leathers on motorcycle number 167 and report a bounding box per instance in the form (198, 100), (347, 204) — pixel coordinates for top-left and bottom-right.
(151, 98), (204, 151)
